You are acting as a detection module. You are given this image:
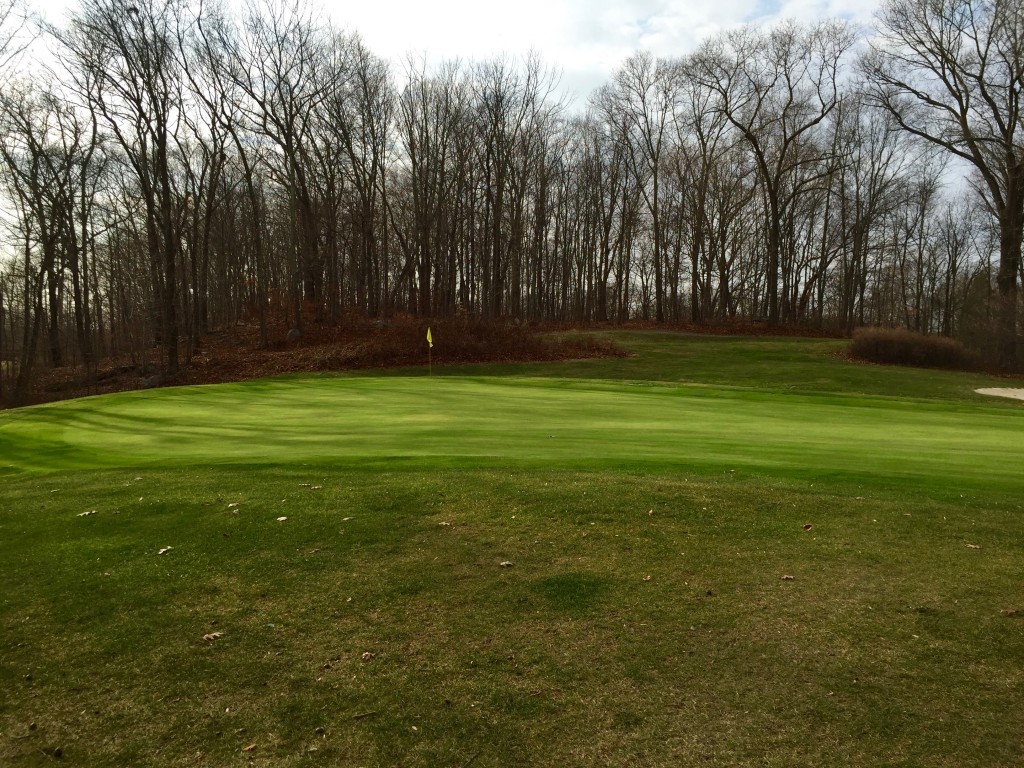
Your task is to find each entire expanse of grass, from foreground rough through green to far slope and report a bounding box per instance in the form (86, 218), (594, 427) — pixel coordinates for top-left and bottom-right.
(0, 334), (1024, 766)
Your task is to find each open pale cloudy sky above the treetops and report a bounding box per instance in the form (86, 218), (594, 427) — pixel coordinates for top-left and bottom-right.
(331, 0), (880, 102)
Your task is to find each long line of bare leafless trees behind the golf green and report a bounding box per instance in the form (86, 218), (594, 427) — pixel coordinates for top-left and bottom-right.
(0, 0), (1024, 399)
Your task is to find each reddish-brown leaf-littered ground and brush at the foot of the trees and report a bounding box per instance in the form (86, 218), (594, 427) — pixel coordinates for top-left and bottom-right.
(8, 315), (840, 409)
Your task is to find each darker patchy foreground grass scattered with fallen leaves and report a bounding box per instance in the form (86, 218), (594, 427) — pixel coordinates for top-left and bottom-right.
(0, 467), (1024, 766)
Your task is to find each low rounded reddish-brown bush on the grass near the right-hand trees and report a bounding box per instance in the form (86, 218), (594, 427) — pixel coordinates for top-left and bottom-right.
(849, 328), (982, 371)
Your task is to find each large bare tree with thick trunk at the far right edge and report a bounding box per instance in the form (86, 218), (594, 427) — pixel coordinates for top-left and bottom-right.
(863, 0), (1024, 370)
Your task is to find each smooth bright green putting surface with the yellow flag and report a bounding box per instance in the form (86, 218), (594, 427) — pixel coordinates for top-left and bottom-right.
(0, 376), (1024, 489)
